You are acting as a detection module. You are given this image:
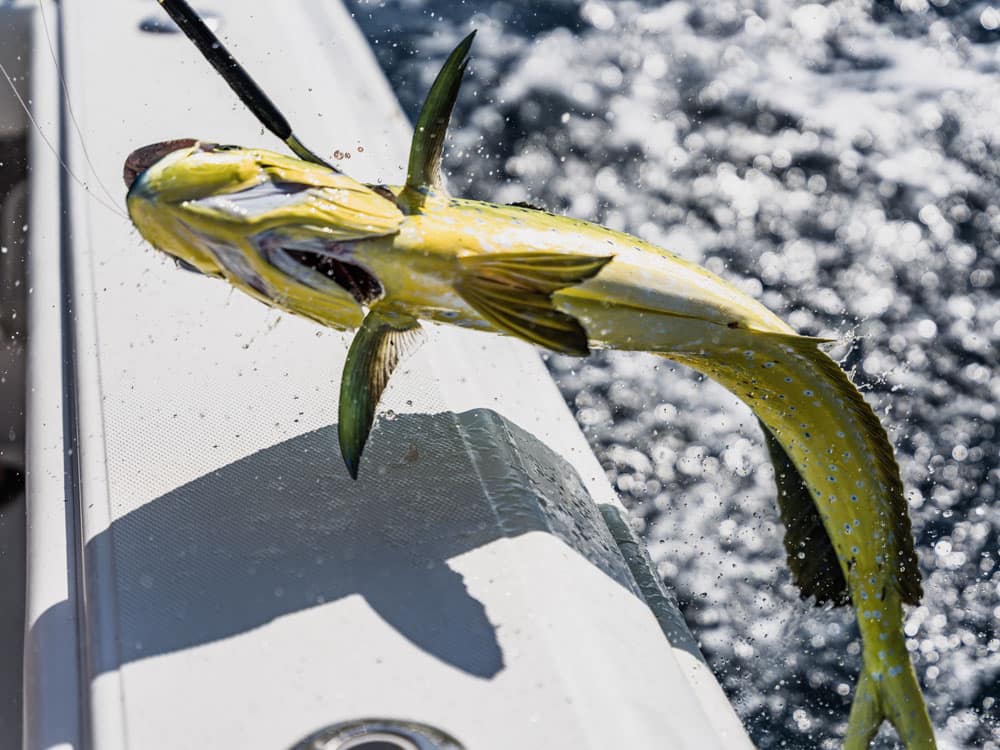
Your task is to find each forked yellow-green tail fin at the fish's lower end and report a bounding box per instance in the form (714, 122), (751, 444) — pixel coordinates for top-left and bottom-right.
(844, 650), (937, 750)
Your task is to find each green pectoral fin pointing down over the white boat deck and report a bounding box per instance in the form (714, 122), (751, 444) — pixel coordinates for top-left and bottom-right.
(338, 310), (423, 479)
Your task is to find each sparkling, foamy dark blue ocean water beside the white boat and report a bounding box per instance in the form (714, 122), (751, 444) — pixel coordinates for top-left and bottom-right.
(350, 0), (1000, 750)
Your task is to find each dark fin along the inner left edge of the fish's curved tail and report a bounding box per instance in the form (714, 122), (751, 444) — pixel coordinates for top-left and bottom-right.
(758, 420), (850, 606)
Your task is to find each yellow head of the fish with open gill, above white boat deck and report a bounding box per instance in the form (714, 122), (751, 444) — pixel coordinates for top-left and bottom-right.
(124, 139), (403, 328)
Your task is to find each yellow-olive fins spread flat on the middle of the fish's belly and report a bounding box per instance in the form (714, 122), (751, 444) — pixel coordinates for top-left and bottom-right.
(455, 253), (613, 357)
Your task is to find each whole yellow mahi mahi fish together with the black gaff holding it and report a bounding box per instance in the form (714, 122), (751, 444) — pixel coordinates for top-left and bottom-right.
(125, 0), (935, 749)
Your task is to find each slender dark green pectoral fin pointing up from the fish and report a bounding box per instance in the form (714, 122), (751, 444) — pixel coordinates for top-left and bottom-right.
(406, 31), (476, 194)
